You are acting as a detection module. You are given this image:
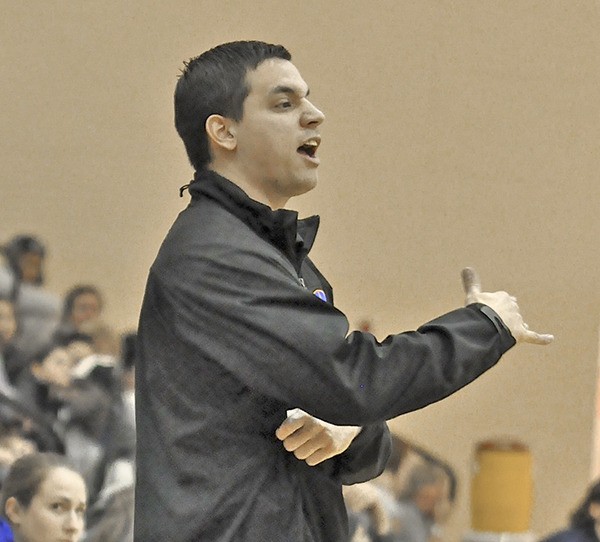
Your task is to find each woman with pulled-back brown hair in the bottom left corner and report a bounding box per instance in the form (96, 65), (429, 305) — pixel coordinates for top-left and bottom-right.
(0, 453), (87, 542)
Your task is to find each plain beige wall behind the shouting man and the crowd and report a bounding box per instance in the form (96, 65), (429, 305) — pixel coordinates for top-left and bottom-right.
(0, 0), (600, 540)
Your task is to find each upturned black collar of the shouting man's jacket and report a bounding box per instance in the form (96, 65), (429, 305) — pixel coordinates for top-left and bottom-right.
(188, 170), (320, 272)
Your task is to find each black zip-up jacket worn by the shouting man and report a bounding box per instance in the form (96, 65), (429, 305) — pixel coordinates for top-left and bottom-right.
(135, 171), (514, 542)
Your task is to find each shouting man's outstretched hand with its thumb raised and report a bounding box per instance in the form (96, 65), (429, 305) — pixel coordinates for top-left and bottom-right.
(462, 267), (554, 344)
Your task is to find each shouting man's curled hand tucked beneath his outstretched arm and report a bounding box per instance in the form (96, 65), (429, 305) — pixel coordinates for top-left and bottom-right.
(275, 408), (361, 467)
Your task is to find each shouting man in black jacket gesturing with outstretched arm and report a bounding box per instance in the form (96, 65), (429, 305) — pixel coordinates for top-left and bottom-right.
(135, 42), (550, 542)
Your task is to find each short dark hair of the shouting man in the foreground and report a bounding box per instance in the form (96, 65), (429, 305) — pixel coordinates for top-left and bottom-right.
(174, 41), (292, 171)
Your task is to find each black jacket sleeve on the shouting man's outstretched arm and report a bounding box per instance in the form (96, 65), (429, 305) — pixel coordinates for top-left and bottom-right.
(154, 243), (515, 426)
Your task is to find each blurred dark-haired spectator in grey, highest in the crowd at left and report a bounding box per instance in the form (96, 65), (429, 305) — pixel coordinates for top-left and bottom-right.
(0, 235), (60, 381)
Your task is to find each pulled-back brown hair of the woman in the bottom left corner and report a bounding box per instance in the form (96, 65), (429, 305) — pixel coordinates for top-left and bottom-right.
(0, 452), (79, 519)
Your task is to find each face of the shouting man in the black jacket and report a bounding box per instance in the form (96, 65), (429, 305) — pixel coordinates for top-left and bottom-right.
(233, 59), (325, 208)
